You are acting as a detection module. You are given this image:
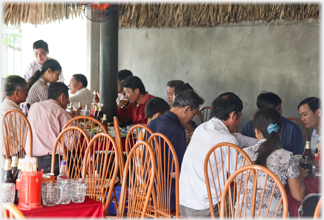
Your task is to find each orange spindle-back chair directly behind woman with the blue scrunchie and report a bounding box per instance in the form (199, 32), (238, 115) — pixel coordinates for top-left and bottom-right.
(220, 165), (288, 218)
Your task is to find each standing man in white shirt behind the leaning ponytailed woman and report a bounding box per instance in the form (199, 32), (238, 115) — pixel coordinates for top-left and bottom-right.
(24, 40), (64, 83)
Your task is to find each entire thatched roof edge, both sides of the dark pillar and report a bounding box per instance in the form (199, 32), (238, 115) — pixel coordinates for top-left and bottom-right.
(3, 3), (320, 28)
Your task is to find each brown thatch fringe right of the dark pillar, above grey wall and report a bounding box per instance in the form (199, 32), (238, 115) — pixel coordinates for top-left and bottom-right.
(119, 3), (320, 28)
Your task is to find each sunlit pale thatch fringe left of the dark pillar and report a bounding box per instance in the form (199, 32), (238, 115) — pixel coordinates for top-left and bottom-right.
(3, 2), (82, 25)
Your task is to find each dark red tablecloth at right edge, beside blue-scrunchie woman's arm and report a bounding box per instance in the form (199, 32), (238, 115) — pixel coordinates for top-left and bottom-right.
(285, 177), (321, 217)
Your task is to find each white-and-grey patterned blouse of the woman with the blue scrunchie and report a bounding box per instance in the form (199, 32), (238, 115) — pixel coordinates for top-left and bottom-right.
(235, 139), (300, 218)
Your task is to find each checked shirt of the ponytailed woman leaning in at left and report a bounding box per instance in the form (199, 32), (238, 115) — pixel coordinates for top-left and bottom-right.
(26, 76), (48, 104)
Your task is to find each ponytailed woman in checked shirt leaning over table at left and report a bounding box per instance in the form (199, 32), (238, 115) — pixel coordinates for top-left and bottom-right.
(26, 59), (62, 105)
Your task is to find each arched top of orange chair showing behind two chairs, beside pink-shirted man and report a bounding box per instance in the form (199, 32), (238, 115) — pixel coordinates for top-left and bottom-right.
(63, 116), (108, 140)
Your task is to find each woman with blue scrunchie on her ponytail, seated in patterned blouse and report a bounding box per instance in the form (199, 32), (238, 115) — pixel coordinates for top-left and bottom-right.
(238, 107), (307, 218)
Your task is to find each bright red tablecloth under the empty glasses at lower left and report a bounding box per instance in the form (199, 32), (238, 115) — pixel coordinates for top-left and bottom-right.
(20, 197), (104, 218)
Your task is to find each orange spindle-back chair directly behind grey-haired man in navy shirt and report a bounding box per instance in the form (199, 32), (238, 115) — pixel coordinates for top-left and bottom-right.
(148, 133), (180, 218)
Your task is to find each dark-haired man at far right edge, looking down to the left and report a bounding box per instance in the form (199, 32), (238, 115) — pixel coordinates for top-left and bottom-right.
(298, 97), (322, 152)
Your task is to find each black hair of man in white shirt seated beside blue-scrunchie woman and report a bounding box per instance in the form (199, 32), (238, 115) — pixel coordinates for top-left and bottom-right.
(210, 92), (243, 121)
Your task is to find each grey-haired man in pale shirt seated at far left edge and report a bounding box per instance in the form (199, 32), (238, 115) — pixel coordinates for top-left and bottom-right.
(0, 75), (27, 155)
